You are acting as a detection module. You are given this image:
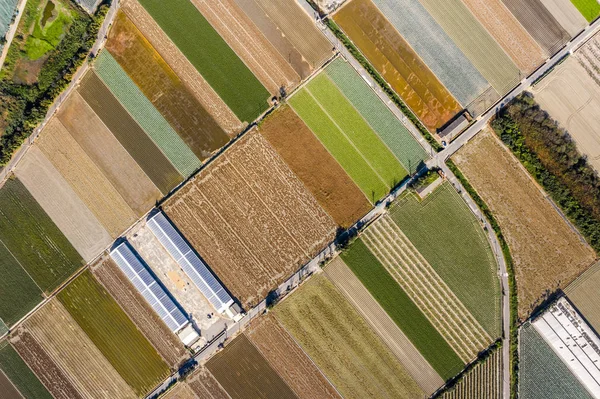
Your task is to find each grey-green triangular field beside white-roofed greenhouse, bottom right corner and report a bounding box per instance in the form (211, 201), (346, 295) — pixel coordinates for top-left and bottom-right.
(519, 323), (592, 399)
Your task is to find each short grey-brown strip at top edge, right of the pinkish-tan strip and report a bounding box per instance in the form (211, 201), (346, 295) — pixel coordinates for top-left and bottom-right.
(502, 0), (571, 56)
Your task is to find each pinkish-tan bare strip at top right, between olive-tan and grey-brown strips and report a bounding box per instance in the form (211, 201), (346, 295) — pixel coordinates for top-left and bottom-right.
(463, 0), (546, 75)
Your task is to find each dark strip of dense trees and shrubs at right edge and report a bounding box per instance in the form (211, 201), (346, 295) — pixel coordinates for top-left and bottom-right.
(492, 93), (600, 253)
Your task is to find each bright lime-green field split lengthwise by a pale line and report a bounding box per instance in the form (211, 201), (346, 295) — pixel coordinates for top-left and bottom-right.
(289, 73), (408, 203)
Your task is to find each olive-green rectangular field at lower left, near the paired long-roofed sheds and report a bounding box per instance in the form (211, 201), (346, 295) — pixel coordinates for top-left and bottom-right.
(58, 270), (169, 396)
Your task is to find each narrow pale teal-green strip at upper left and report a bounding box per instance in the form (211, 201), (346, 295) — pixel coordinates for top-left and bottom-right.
(94, 51), (201, 177)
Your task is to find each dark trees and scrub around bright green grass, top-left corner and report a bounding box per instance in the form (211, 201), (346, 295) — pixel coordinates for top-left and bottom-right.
(0, 1), (108, 165)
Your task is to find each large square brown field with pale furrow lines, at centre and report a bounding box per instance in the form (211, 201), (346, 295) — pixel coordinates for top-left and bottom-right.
(163, 130), (335, 306)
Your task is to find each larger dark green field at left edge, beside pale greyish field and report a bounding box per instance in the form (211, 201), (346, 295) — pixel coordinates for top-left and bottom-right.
(0, 178), (84, 292)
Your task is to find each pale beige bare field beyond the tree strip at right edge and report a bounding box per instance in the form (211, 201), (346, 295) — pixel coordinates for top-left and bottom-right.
(533, 57), (600, 171)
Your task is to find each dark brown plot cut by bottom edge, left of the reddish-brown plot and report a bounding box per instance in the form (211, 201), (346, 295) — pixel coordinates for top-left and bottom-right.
(206, 334), (297, 399)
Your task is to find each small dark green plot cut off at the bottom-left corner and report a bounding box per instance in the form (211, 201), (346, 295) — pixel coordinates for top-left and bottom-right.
(0, 341), (52, 399)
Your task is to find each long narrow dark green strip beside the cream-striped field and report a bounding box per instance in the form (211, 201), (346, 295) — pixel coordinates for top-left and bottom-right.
(341, 239), (465, 380)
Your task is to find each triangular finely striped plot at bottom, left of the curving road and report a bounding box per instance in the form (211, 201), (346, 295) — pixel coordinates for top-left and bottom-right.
(441, 349), (502, 399)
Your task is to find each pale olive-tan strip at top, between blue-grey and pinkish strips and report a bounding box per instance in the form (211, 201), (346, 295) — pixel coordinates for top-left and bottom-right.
(421, 0), (521, 95)
